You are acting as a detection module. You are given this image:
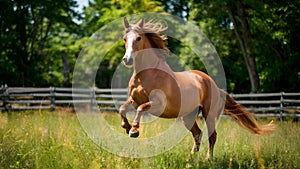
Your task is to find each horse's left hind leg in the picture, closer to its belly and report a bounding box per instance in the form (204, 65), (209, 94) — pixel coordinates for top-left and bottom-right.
(182, 108), (202, 154)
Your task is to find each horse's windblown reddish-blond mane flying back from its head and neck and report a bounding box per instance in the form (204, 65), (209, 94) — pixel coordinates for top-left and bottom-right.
(125, 20), (169, 58)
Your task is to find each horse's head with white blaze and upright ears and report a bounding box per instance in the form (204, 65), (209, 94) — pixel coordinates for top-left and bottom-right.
(123, 18), (144, 67)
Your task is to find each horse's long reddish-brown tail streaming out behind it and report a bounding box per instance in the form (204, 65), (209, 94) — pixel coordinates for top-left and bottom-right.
(225, 93), (275, 135)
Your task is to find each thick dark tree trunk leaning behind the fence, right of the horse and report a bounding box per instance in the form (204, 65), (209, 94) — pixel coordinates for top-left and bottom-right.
(229, 0), (259, 92)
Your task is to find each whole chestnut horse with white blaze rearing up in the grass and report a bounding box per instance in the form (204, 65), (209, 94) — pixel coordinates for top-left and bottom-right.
(119, 17), (275, 159)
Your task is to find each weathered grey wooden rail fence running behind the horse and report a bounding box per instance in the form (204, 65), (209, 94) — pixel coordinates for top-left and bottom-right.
(0, 87), (300, 119)
